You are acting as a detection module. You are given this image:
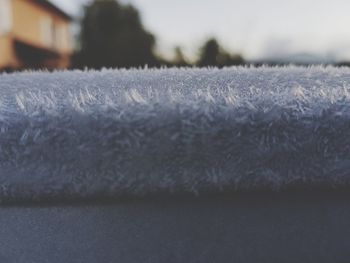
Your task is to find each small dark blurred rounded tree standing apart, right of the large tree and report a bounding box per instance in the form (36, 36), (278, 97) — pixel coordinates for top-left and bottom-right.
(197, 38), (244, 67)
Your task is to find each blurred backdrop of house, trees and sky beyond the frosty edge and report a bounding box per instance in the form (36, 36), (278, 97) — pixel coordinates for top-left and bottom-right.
(0, 0), (350, 71)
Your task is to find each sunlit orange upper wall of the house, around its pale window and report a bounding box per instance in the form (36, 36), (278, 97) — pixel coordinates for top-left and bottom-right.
(12, 0), (71, 53)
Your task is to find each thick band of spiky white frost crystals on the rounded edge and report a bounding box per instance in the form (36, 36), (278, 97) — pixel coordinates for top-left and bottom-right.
(0, 67), (350, 201)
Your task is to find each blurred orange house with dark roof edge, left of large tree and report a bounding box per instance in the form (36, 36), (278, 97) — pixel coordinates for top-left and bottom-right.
(0, 0), (72, 70)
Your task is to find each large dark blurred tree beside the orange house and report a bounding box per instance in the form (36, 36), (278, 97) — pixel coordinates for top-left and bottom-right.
(76, 0), (158, 68)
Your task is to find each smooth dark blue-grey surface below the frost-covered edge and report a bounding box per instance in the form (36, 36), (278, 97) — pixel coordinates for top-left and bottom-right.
(0, 193), (350, 263)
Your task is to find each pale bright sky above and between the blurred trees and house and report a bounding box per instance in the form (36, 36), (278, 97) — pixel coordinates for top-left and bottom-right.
(51, 0), (350, 60)
